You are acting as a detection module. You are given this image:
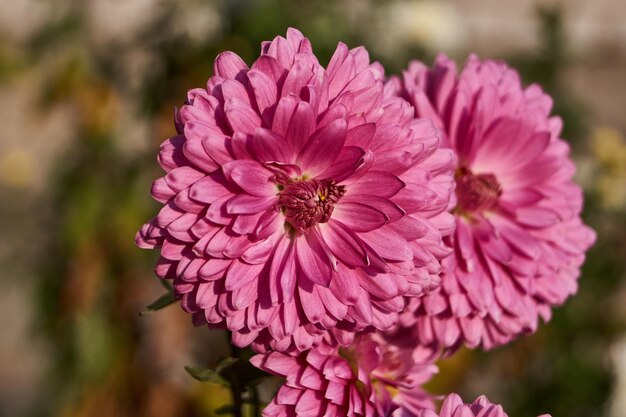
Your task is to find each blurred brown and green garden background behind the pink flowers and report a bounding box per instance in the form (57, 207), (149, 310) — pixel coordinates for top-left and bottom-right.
(0, 0), (626, 417)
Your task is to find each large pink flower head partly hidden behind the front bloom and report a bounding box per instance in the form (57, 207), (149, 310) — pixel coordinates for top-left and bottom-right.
(386, 56), (595, 349)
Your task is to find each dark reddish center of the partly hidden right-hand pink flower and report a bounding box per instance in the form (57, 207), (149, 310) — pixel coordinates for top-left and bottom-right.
(455, 168), (502, 212)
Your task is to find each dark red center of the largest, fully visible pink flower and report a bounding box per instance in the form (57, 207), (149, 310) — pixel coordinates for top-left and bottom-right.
(278, 179), (346, 232)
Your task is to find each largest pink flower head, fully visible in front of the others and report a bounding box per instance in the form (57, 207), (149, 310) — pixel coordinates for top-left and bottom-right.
(136, 29), (454, 351)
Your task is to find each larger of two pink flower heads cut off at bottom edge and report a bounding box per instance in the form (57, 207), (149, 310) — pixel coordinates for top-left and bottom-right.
(251, 334), (437, 417)
